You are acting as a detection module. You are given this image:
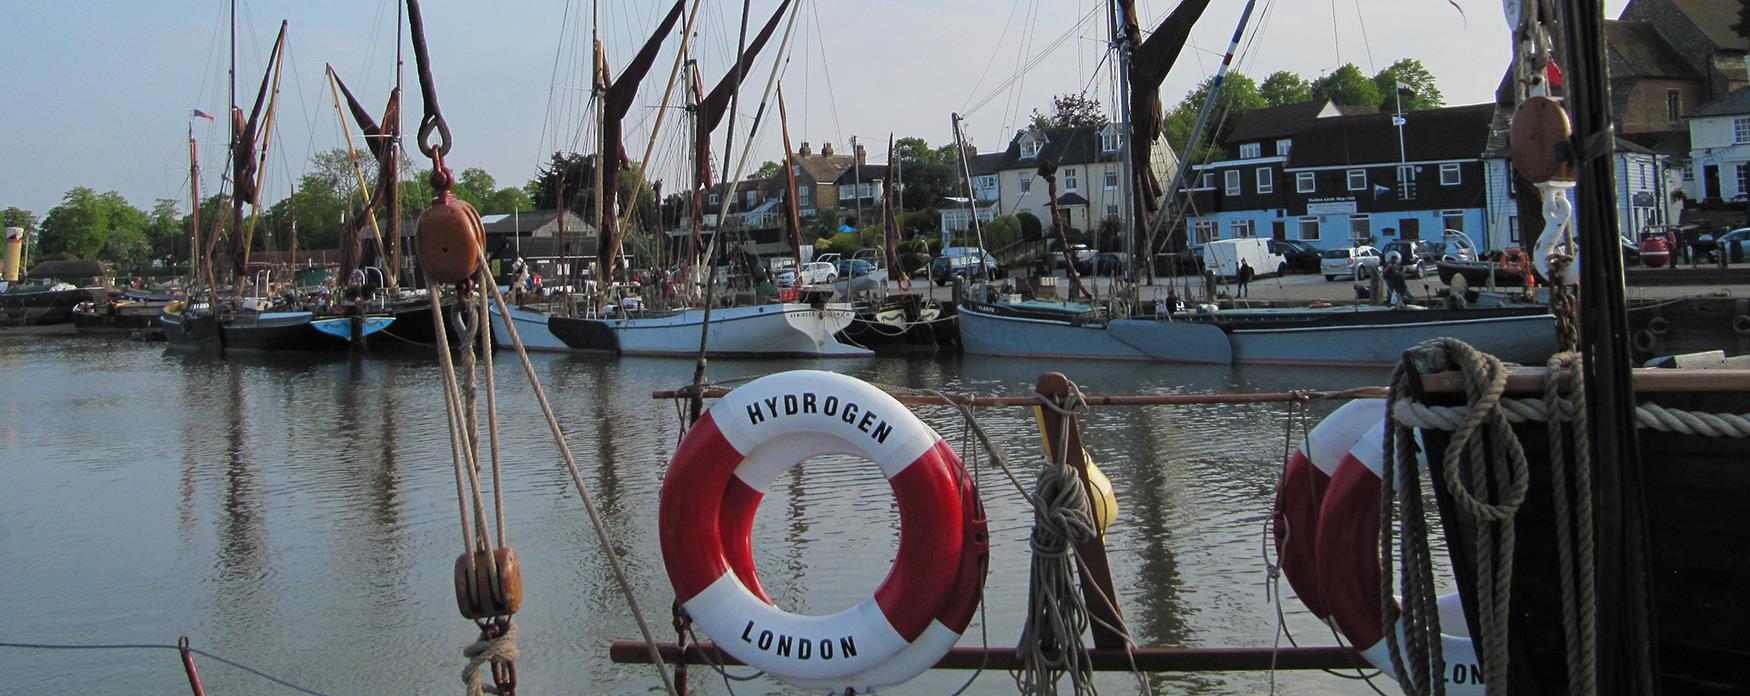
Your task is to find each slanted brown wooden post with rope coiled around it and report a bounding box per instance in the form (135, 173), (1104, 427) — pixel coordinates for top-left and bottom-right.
(1033, 372), (1125, 652)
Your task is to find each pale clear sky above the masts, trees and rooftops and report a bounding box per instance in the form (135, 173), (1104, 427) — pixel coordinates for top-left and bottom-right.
(0, 0), (1624, 215)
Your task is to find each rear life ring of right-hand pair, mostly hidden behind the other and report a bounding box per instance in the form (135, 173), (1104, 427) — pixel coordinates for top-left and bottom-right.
(1272, 399), (1386, 619)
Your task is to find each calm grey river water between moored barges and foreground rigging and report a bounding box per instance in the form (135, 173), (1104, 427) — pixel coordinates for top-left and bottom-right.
(0, 336), (1391, 694)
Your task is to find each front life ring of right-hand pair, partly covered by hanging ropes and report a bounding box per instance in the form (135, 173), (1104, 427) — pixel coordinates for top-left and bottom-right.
(1314, 411), (1484, 694)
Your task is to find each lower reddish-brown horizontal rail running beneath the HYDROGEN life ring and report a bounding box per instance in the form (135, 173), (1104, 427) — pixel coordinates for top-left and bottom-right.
(607, 640), (1370, 672)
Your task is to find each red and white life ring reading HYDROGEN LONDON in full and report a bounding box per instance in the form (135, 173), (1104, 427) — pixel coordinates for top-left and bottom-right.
(658, 371), (989, 693)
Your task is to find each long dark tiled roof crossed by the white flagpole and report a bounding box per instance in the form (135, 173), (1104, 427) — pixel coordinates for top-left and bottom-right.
(1288, 103), (1495, 168)
